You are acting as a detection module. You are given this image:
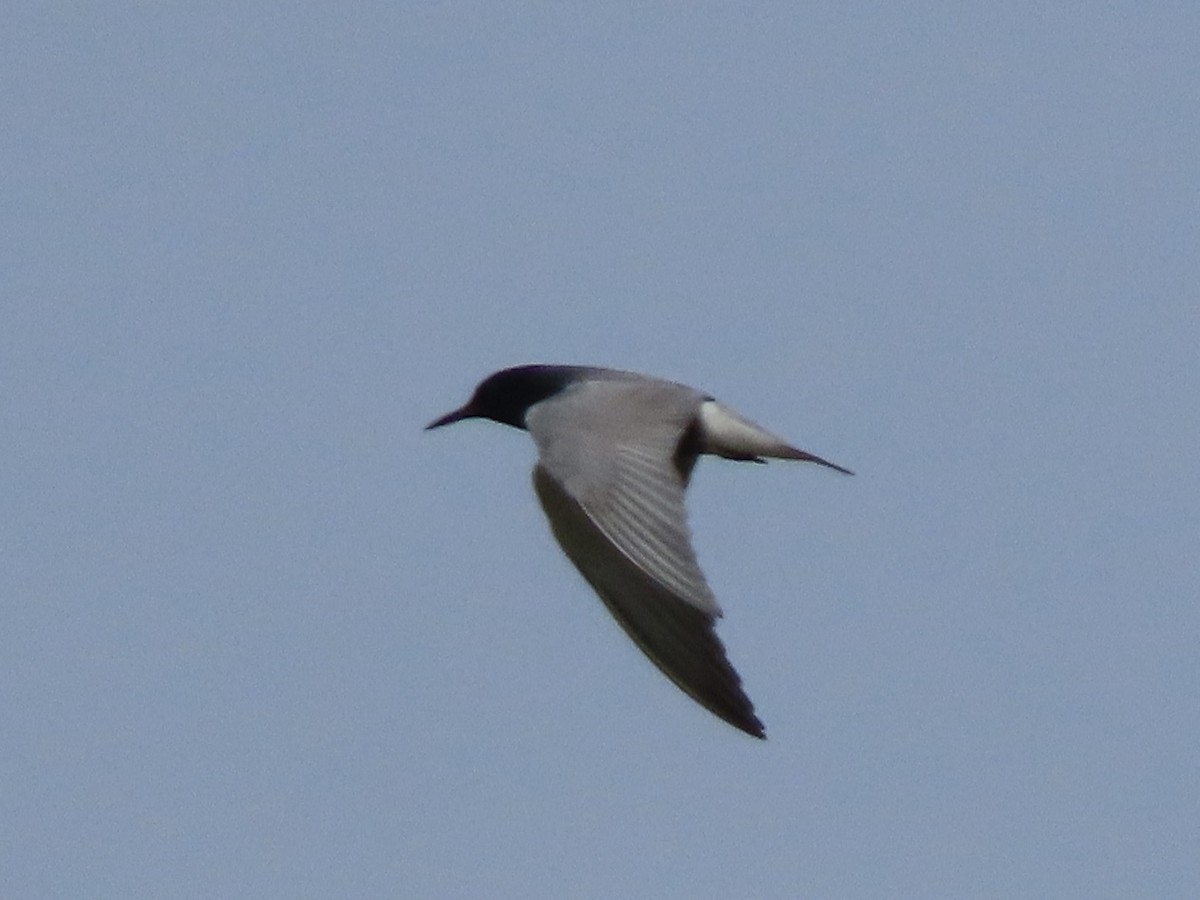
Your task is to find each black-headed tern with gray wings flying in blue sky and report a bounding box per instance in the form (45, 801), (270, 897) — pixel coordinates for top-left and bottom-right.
(426, 366), (853, 738)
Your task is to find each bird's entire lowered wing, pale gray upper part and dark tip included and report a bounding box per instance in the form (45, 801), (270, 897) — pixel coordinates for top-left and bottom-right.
(526, 382), (764, 738)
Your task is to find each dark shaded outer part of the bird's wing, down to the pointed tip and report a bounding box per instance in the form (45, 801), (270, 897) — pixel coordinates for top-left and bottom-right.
(533, 466), (766, 738)
